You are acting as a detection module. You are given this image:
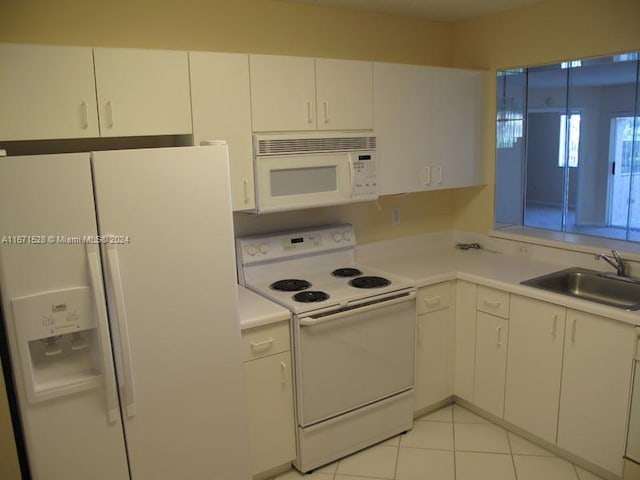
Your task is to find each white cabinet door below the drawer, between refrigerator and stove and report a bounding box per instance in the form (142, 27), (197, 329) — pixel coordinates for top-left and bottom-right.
(244, 351), (296, 475)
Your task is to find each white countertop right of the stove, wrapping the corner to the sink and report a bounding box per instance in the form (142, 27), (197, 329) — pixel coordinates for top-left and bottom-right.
(357, 241), (640, 325)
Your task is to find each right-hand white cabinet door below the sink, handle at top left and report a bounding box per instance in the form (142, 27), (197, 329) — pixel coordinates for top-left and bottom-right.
(557, 310), (636, 475)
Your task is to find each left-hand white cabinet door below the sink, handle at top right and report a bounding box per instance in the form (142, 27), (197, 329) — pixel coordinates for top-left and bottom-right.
(504, 295), (566, 443)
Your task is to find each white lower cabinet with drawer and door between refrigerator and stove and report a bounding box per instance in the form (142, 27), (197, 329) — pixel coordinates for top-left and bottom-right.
(242, 321), (296, 476)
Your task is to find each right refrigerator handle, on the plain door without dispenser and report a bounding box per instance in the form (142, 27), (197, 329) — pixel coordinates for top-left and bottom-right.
(106, 243), (136, 417)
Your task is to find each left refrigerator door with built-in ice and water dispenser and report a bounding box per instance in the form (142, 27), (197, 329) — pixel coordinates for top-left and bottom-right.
(0, 154), (129, 480)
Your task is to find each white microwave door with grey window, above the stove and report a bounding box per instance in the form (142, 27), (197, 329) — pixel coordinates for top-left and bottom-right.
(255, 153), (353, 213)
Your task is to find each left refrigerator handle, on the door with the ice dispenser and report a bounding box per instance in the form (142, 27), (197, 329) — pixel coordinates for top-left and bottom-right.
(87, 243), (119, 423)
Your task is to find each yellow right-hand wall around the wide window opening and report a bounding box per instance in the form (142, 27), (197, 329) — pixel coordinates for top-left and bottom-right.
(453, 0), (640, 233)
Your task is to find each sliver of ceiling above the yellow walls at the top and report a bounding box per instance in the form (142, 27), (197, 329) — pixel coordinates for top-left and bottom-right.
(285, 0), (541, 22)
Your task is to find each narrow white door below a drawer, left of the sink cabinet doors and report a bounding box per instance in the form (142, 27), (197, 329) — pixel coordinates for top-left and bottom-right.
(473, 312), (509, 418)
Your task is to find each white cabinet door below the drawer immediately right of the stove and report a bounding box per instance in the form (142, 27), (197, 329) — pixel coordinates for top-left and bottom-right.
(413, 308), (449, 411)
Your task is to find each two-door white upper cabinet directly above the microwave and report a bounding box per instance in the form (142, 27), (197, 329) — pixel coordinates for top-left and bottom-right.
(250, 55), (373, 132)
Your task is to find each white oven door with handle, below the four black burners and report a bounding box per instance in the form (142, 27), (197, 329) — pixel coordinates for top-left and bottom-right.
(294, 292), (416, 427)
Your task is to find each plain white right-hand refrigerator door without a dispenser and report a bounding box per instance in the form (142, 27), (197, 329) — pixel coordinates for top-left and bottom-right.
(92, 146), (251, 480)
